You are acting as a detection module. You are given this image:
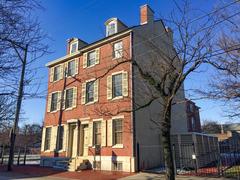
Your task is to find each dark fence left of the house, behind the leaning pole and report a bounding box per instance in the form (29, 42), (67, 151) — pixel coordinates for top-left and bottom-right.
(0, 145), (40, 165)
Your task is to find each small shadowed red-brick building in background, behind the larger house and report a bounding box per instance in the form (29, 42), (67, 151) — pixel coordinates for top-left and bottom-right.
(186, 99), (202, 133)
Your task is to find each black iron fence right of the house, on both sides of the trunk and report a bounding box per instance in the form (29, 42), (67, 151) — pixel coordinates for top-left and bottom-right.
(139, 143), (240, 179)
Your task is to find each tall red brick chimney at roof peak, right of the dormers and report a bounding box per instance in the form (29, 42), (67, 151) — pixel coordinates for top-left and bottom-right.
(140, 4), (154, 25)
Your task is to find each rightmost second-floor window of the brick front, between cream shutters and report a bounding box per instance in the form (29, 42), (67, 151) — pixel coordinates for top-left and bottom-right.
(112, 74), (122, 98)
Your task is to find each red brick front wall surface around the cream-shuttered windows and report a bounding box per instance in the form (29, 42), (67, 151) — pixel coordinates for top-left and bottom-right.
(44, 35), (132, 156)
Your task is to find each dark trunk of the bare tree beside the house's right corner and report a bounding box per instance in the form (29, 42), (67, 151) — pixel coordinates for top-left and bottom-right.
(161, 102), (175, 180)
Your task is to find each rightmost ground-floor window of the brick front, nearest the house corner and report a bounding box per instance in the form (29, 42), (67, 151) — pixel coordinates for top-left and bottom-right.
(113, 119), (123, 145)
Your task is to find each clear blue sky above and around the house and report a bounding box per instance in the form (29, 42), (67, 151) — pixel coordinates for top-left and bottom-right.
(23, 0), (230, 123)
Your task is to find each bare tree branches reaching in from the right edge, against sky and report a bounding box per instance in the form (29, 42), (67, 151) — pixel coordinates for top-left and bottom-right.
(200, 1), (240, 118)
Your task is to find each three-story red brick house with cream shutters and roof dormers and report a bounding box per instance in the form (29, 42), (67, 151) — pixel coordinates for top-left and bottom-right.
(41, 5), (188, 172)
